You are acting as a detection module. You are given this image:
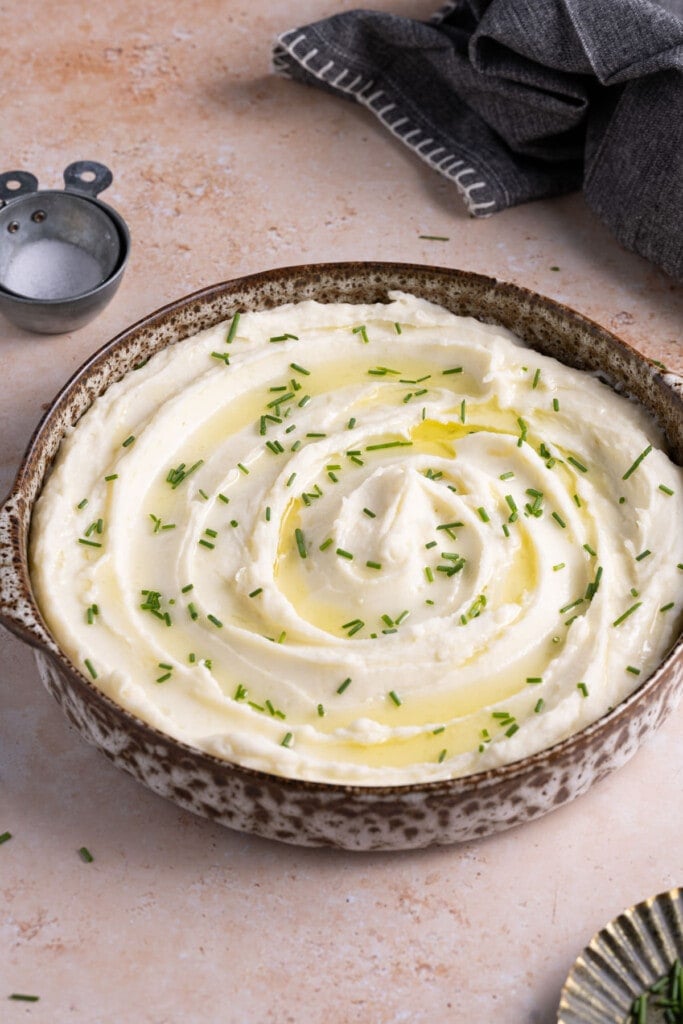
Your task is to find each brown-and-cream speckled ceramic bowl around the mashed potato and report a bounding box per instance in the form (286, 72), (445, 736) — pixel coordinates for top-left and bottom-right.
(0, 263), (683, 850)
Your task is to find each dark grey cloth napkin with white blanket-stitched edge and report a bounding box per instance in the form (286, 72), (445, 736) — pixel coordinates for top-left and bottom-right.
(272, 0), (683, 279)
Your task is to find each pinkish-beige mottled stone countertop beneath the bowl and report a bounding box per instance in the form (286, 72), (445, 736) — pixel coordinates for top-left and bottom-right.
(0, 0), (683, 1024)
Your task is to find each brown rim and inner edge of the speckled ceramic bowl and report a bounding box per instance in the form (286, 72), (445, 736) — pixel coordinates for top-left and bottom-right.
(0, 262), (683, 799)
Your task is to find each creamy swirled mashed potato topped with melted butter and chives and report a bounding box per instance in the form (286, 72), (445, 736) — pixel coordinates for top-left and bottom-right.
(32, 293), (683, 785)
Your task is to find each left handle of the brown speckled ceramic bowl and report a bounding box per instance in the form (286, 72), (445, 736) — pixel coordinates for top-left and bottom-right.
(0, 493), (56, 650)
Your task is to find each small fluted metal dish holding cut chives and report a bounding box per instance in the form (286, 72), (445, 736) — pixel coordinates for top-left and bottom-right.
(557, 889), (683, 1024)
